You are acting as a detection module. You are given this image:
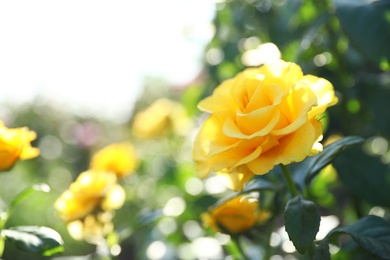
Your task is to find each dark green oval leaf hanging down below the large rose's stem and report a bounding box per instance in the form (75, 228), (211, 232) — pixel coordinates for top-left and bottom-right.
(284, 196), (321, 254)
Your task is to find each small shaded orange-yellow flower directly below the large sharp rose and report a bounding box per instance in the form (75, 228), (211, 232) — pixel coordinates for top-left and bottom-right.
(202, 195), (270, 234)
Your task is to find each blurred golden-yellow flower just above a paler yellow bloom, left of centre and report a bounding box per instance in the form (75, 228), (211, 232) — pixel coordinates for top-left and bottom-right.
(90, 142), (138, 178)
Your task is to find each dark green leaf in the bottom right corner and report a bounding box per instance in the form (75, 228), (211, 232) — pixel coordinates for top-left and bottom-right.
(328, 216), (390, 259)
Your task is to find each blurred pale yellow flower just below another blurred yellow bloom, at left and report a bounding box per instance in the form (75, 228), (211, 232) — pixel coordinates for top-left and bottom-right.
(54, 170), (119, 222)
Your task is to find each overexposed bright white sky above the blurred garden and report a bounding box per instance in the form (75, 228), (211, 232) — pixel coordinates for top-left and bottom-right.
(0, 0), (214, 120)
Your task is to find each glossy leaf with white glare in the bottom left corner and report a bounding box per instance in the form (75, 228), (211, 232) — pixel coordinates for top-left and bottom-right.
(2, 226), (64, 256)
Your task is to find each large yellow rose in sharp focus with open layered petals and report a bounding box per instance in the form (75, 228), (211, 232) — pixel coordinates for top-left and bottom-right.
(193, 60), (337, 190)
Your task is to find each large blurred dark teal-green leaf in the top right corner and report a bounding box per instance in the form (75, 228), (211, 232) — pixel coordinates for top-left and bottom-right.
(334, 0), (390, 65)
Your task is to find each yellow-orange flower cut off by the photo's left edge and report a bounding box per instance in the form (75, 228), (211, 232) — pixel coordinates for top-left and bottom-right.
(0, 121), (39, 170)
